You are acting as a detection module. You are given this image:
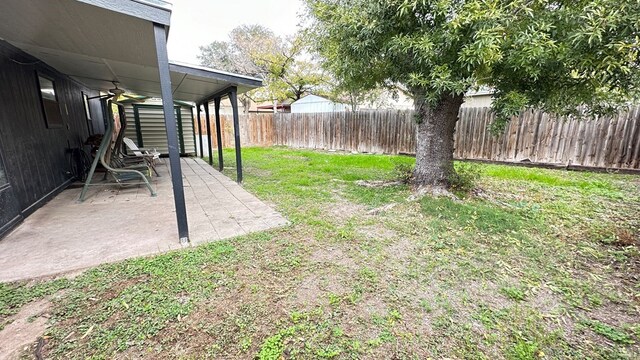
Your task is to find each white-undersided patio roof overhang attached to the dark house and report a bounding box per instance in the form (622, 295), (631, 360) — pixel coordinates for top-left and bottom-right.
(0, 0), (262, 102)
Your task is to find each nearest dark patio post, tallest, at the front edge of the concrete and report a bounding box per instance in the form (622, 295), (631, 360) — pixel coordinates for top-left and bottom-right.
(153, 23), (189, 244)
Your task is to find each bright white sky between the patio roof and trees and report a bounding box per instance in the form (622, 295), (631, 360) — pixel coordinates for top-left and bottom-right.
(168, 0), (303, 64)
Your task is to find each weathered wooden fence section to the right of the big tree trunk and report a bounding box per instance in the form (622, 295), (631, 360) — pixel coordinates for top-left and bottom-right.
(454, 107), (640, 169)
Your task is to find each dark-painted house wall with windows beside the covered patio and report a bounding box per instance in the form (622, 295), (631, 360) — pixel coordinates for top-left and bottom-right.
(0, 41), (103, 236)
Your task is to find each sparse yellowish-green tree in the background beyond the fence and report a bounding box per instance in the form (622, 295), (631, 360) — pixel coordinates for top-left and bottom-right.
(198, 25), (326, 110)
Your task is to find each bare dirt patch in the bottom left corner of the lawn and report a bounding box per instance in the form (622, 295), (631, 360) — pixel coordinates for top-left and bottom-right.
(0, 299), (51, 360)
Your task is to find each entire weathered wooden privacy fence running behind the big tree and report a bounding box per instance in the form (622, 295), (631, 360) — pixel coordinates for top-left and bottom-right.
(196, 107), (640, 169)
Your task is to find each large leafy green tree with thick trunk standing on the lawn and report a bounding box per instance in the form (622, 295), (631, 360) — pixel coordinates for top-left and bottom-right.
(305, 0), (640, 187)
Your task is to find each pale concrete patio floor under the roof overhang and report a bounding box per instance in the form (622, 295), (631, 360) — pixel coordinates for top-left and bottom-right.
(0, 158), (288, 282)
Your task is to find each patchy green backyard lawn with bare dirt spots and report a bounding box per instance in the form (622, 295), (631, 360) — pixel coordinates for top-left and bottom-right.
(0, 148), (640, 359)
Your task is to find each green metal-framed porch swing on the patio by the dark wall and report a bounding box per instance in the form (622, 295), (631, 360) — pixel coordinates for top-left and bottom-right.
(78, 93), (157, 202)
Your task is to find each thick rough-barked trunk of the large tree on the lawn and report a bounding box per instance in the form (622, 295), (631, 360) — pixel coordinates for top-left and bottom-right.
(414, 94), (463, 188)
